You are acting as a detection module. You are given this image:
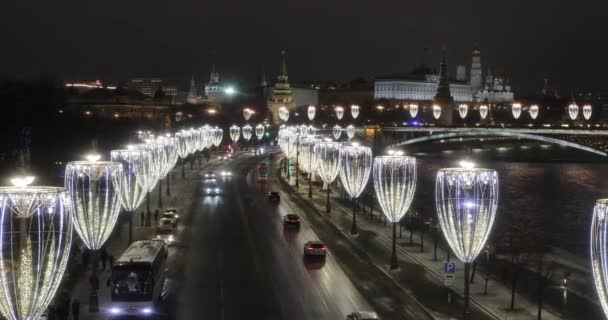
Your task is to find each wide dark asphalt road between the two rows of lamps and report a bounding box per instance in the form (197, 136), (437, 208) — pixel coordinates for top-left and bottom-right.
(177, 157), (371, 320)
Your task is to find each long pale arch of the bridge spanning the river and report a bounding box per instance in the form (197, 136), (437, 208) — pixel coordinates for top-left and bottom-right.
(387, 130), (608, 157)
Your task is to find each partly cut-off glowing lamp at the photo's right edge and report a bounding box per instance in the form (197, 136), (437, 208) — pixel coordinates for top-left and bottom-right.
(591, 199), (608, 317)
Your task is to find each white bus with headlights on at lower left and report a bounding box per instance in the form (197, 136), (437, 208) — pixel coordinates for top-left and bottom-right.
(108, 240), (168, 315)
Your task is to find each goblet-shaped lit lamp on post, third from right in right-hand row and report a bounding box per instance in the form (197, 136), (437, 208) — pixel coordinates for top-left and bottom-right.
(372, 151), (416, 269)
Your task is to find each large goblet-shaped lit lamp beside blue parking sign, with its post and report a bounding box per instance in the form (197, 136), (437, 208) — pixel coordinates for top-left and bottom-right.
(435, 165), (498, 319)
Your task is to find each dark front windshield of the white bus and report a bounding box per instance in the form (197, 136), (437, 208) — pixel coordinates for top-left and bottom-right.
(110, 266), (154, 301)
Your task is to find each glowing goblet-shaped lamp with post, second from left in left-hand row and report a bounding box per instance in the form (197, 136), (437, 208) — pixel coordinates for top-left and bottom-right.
(65, 155), (124, 312)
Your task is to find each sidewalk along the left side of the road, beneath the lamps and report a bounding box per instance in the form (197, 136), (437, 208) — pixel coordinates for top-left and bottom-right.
(58, 160), (216, 320)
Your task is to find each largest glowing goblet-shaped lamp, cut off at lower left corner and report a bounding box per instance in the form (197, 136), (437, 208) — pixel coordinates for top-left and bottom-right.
(0, 177), (73, 320)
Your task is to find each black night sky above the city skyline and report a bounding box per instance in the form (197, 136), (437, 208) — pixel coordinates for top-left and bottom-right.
(0, 0), (608, 94)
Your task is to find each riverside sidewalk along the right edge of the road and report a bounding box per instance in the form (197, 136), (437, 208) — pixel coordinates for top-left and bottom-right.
(278, 158), (572, 320)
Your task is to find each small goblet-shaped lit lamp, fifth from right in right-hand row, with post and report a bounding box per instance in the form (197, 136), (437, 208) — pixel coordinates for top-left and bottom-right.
(313, 141), (342, 213)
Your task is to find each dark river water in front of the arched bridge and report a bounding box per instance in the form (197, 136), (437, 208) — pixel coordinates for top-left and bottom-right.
(414, 144), (608, 256)
